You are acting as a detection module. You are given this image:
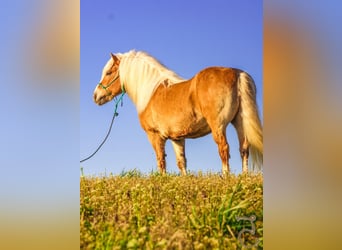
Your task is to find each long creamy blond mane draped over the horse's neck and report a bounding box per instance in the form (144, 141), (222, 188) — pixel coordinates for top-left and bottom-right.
(116, 50), (185, 113)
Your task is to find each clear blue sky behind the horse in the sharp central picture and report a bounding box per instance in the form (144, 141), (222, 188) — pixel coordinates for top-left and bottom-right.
(80, 0), (263, 175)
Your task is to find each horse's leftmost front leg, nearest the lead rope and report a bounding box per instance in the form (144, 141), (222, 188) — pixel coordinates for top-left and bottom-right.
(147, 132), (166, 174)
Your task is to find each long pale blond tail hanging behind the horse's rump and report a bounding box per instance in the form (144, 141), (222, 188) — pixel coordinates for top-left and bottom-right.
(239, 72), (263, 169)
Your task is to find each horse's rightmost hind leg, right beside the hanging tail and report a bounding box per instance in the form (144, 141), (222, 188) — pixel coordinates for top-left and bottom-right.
(232, 113), (249, 173)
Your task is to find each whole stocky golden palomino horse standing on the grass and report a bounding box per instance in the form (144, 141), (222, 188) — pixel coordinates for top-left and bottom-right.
(94, 50), (263, 175)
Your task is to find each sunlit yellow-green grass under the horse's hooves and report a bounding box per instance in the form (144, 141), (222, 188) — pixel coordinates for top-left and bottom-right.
(80, 170), (263, 249)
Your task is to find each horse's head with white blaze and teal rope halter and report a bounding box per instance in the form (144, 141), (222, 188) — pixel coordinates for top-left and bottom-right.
(94, 54), (123, 105)
